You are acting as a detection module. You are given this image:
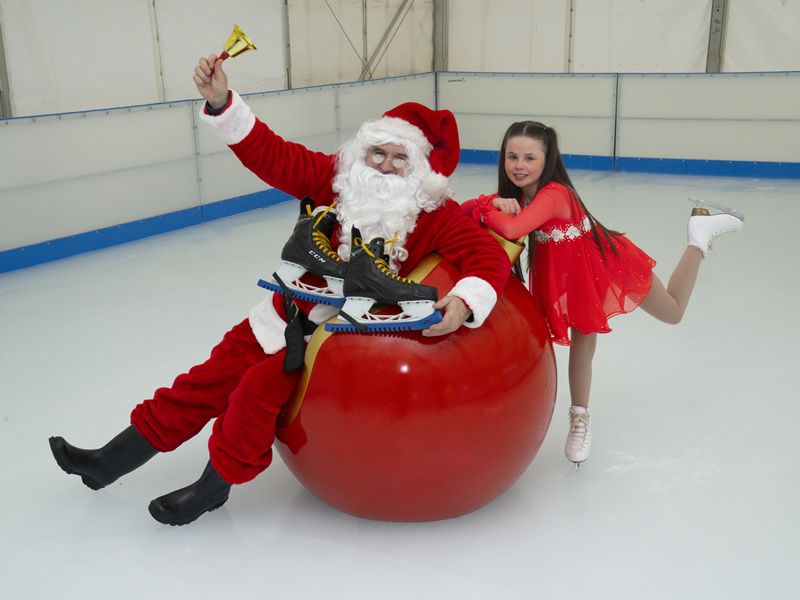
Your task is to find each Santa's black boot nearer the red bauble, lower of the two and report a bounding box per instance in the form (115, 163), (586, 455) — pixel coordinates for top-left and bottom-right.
(147, 461), (231, 525)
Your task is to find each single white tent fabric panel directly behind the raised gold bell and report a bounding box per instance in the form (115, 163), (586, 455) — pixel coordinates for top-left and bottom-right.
(156, 0), (286, 100)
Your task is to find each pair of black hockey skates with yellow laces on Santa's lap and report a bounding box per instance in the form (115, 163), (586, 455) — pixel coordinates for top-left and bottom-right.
(258, 198), (442, 332)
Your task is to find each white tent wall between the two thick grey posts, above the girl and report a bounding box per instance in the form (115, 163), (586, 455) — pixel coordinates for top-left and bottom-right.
(448, 0), (711, 73)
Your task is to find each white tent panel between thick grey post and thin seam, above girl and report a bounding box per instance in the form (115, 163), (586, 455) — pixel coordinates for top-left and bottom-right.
(448, 0), (569, 73)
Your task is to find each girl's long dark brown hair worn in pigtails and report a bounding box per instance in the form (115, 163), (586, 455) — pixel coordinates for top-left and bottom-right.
(497, 121), (620, 279)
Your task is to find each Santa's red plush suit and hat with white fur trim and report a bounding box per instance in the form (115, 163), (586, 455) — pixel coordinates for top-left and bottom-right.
(131, 92), (510, 483)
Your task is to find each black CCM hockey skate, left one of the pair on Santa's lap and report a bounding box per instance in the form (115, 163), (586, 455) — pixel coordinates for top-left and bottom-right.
(258, 198), (347, 306)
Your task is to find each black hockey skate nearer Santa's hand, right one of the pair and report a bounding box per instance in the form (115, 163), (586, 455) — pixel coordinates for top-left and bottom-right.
(325, 227), (442, 333)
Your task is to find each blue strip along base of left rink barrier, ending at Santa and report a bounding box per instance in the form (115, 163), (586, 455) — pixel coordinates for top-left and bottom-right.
(0, 189), (291, 273)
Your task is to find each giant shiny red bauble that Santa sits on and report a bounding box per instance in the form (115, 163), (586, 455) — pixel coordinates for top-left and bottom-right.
(278, 261), (556, 521)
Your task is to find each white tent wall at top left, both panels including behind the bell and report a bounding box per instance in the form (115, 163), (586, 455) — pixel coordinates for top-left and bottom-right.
(0, 0), (285, 116)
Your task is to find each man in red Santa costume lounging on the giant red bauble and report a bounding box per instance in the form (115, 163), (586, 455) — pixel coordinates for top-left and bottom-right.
(50, 55), (510, 525)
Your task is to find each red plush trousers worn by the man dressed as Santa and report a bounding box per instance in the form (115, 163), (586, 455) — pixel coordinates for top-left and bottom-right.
(131, 319), (300, 483)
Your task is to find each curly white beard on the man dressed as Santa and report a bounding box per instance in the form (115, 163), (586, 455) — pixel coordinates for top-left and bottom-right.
(333, 144), (439, 273)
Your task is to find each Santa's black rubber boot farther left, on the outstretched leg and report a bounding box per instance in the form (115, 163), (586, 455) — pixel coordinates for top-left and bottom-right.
(50, 425), (158, 490)
